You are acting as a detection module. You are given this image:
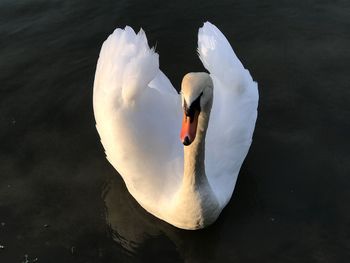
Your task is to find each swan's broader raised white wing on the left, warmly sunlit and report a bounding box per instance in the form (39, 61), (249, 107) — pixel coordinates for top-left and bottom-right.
(94, 27), (183, 209)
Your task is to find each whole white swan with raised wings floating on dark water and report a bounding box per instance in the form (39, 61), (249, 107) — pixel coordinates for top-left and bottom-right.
(93, 22), (259, 230)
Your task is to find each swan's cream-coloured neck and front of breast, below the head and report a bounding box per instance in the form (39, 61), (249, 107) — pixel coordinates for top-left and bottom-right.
(172, 108), (221, 229)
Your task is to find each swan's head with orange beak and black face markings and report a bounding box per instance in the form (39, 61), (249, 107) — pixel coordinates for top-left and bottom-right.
(180, 72), (213, 146)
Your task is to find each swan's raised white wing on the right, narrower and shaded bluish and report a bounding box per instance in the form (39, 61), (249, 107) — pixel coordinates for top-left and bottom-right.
(198, 22), (259, 204)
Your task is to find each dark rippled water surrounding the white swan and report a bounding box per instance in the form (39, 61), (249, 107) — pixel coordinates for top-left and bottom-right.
(0, 0), (350, 263)
